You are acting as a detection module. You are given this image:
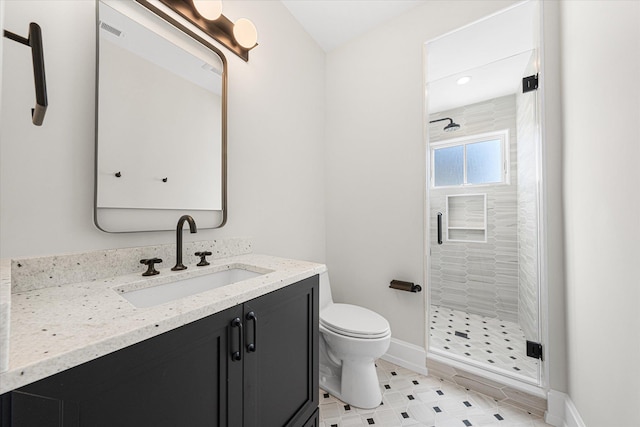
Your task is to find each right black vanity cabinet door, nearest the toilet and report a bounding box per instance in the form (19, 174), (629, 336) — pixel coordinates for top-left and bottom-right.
(244, 276), (318, 427)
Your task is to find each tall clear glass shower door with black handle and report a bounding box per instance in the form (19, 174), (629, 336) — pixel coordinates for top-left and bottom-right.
(425, 0), (544, 387)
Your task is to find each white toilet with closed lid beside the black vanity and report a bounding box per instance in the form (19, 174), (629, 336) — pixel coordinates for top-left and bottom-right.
(320, 272), (391, 409)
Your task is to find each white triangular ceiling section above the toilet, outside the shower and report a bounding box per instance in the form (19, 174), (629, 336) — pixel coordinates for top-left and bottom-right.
(281, 0), (428, 52)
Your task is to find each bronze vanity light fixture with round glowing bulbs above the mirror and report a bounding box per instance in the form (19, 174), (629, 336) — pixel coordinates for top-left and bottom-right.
(135, 0), (258, 62)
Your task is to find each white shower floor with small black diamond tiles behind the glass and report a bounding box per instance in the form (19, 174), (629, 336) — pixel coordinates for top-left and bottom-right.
(429, 305), (538, 379)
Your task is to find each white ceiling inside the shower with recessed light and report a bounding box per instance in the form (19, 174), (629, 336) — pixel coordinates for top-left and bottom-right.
(425, 2), (537, 113)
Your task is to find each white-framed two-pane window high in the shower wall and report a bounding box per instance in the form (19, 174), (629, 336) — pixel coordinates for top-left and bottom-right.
(431, 130), (509, 187)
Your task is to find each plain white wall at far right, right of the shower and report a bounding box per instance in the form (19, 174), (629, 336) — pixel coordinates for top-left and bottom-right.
(561, 1), (640, 427)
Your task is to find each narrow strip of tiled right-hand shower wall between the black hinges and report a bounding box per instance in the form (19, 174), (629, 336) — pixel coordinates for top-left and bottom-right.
(516, 54), (538, 340)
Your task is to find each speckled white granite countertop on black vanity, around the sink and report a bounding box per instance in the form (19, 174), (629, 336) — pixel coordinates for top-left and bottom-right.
(0, 253), (326, 394)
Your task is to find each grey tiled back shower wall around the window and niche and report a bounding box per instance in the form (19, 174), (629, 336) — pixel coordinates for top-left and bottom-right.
(429, 95), (519, 322)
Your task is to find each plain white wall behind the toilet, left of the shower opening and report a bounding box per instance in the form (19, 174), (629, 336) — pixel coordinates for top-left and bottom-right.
(326, 1), (513, 346)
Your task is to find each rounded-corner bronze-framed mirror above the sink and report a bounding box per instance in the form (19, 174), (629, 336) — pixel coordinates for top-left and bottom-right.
(95, 0), (227, 232)
